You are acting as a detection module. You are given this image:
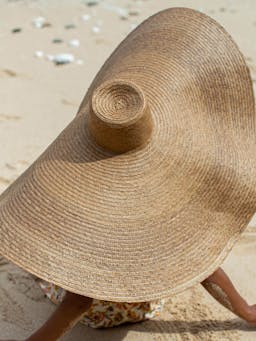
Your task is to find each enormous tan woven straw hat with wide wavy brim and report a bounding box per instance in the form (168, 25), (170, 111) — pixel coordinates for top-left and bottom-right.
(0, 8), (256, 302)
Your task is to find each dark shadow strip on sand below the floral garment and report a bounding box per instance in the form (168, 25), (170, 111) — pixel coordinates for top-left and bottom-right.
(64, 318), (256, 341)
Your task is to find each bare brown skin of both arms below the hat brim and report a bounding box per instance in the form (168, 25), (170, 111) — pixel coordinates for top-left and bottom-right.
(0, 268), (256, 341)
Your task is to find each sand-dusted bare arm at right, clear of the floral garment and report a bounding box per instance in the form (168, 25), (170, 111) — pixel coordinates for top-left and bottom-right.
(201, 268), (256, 323)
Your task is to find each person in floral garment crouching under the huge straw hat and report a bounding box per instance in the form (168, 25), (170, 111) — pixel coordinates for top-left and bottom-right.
(1, 268), (256, 341)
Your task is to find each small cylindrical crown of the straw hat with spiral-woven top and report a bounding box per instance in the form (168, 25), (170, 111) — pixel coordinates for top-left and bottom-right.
(88, 79), (153, 153)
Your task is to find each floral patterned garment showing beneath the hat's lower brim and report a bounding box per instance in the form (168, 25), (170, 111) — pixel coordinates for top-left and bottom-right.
(37, 279), (165, 328)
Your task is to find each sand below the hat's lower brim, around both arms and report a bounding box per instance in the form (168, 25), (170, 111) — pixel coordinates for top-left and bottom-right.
(0, 228), (256, 341)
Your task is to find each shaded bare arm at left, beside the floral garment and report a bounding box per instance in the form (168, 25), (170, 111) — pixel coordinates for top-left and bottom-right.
(27, 292), (92, 341)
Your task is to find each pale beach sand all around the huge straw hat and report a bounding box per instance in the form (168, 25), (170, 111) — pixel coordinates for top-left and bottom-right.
(0, 0), (256, 341)
